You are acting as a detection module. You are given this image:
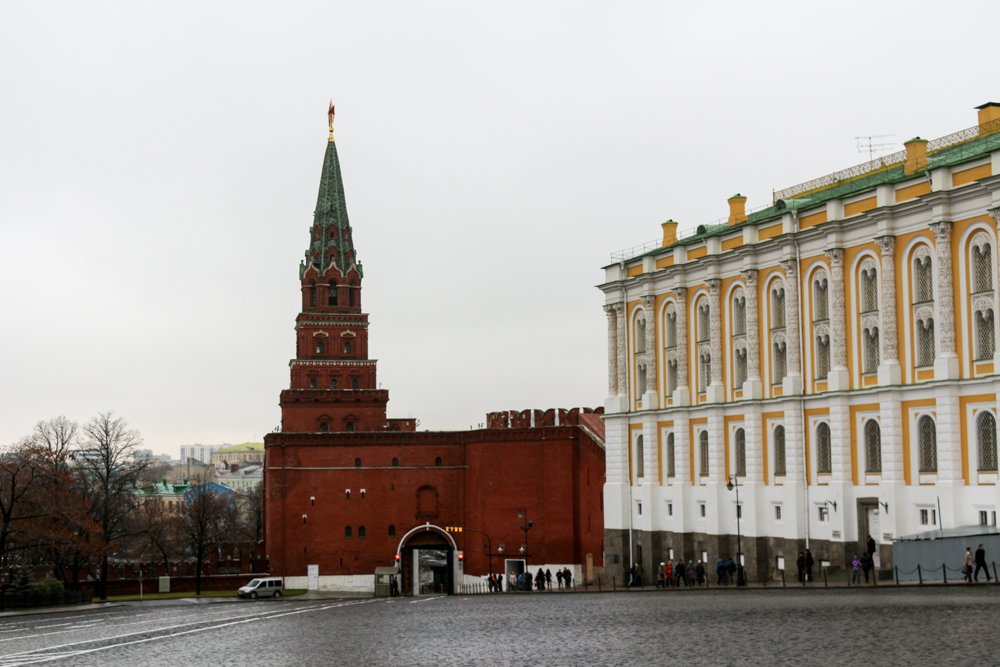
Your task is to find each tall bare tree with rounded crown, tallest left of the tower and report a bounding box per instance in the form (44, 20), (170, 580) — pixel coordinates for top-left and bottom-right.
(76, 411), (149, 600)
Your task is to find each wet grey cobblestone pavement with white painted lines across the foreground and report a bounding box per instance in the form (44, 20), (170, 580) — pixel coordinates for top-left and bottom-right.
(0, 586), (1000, 667)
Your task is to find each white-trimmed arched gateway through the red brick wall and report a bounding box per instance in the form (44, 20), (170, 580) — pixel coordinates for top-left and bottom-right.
(396, 522), (462, 595)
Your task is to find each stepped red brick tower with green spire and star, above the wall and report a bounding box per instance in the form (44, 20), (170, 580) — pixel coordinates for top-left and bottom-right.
(280, 105), (406, 433)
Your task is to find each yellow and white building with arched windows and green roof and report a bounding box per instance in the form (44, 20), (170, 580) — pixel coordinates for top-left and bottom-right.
(600, 103), (1000, 579)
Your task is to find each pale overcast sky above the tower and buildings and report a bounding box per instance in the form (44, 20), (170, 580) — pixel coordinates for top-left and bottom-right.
(0, 0), (1000, 456)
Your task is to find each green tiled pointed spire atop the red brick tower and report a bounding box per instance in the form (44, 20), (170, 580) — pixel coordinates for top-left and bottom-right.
(299, 136), (362, 277)
